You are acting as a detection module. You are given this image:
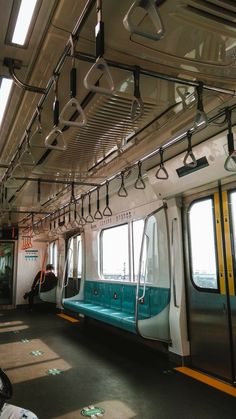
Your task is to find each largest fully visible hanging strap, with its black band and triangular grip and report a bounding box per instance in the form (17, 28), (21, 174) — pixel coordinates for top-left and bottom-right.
(84, 0), (115, 95)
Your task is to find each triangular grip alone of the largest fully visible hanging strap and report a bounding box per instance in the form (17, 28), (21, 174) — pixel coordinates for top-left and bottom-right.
(84, 57), (115, 95)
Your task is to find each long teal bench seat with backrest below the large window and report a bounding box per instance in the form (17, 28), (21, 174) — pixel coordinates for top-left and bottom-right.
(63, 280), (170, 333)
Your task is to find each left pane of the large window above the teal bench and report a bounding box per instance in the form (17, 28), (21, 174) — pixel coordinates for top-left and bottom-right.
(101, 224), (129, 281)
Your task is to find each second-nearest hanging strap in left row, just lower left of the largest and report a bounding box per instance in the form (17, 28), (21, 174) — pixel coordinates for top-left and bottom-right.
(59, 35), (87, 128)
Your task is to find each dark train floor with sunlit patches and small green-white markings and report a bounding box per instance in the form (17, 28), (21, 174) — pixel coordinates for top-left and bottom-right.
(0, 307), (236, 419)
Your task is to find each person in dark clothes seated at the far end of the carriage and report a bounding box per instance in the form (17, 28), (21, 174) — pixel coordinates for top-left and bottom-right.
(24, 263), (58, 308)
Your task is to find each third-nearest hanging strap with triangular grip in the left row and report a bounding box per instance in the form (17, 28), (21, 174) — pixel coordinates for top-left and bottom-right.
(45, 75), (67, 151)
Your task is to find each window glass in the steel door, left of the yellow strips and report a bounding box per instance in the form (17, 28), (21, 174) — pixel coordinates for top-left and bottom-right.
(189, 199), (218, 289)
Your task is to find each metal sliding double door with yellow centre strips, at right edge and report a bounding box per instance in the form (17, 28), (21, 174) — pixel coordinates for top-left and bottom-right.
(186, 189), (236, 383)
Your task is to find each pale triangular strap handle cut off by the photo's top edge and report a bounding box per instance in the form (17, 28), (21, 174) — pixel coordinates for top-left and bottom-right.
(123, 0), (165, 41)
